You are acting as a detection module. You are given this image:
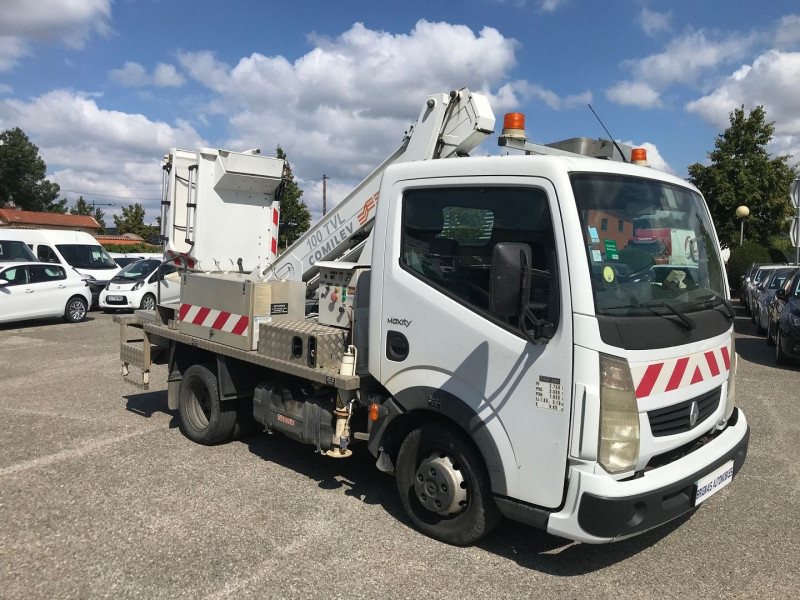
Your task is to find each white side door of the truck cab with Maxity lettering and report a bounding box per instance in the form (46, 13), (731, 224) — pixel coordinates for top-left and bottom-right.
(370, 177), (572, 507)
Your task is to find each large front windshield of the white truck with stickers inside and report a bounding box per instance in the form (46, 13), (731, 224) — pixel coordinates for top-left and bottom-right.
(571, 173), (724, 316)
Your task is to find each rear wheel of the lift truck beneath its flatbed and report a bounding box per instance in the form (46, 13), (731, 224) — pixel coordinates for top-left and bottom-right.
(178, 365), (236, 446)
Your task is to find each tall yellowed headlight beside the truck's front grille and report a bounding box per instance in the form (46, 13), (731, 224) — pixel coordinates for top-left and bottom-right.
(598, 354), (640, 473)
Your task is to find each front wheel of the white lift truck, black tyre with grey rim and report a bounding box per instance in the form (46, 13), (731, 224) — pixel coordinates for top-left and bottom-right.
(397, 421), (500, 546)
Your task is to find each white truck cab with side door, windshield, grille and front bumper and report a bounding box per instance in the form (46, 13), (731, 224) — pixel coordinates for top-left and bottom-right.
(366, 156), (748, 542)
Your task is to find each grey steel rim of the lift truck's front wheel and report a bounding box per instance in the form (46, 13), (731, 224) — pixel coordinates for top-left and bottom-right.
(414, 452), (467, 516)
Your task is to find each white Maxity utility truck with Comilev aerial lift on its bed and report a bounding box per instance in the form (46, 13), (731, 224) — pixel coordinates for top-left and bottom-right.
(118, 89), (749, 544)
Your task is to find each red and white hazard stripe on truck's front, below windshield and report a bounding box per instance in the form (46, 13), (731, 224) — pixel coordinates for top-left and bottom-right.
(631, 346), (731, 398)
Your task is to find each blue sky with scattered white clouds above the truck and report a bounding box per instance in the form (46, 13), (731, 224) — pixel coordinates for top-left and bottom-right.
(0, 0), (800, 225)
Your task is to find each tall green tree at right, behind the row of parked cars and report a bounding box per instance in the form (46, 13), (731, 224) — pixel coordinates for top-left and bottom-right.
(689, 106), (796, 248)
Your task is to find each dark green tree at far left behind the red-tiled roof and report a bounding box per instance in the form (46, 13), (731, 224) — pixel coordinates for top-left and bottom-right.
(0, 127), (62, 213)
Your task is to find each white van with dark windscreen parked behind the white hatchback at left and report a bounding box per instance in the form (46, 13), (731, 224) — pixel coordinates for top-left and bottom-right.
(9, 229), (119, 304)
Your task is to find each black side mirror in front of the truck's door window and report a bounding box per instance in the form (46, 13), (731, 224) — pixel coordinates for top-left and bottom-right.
(489, 242), (532, 317)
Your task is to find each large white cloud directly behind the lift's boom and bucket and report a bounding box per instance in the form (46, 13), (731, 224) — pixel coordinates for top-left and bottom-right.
(178, 20), (517, 209)
